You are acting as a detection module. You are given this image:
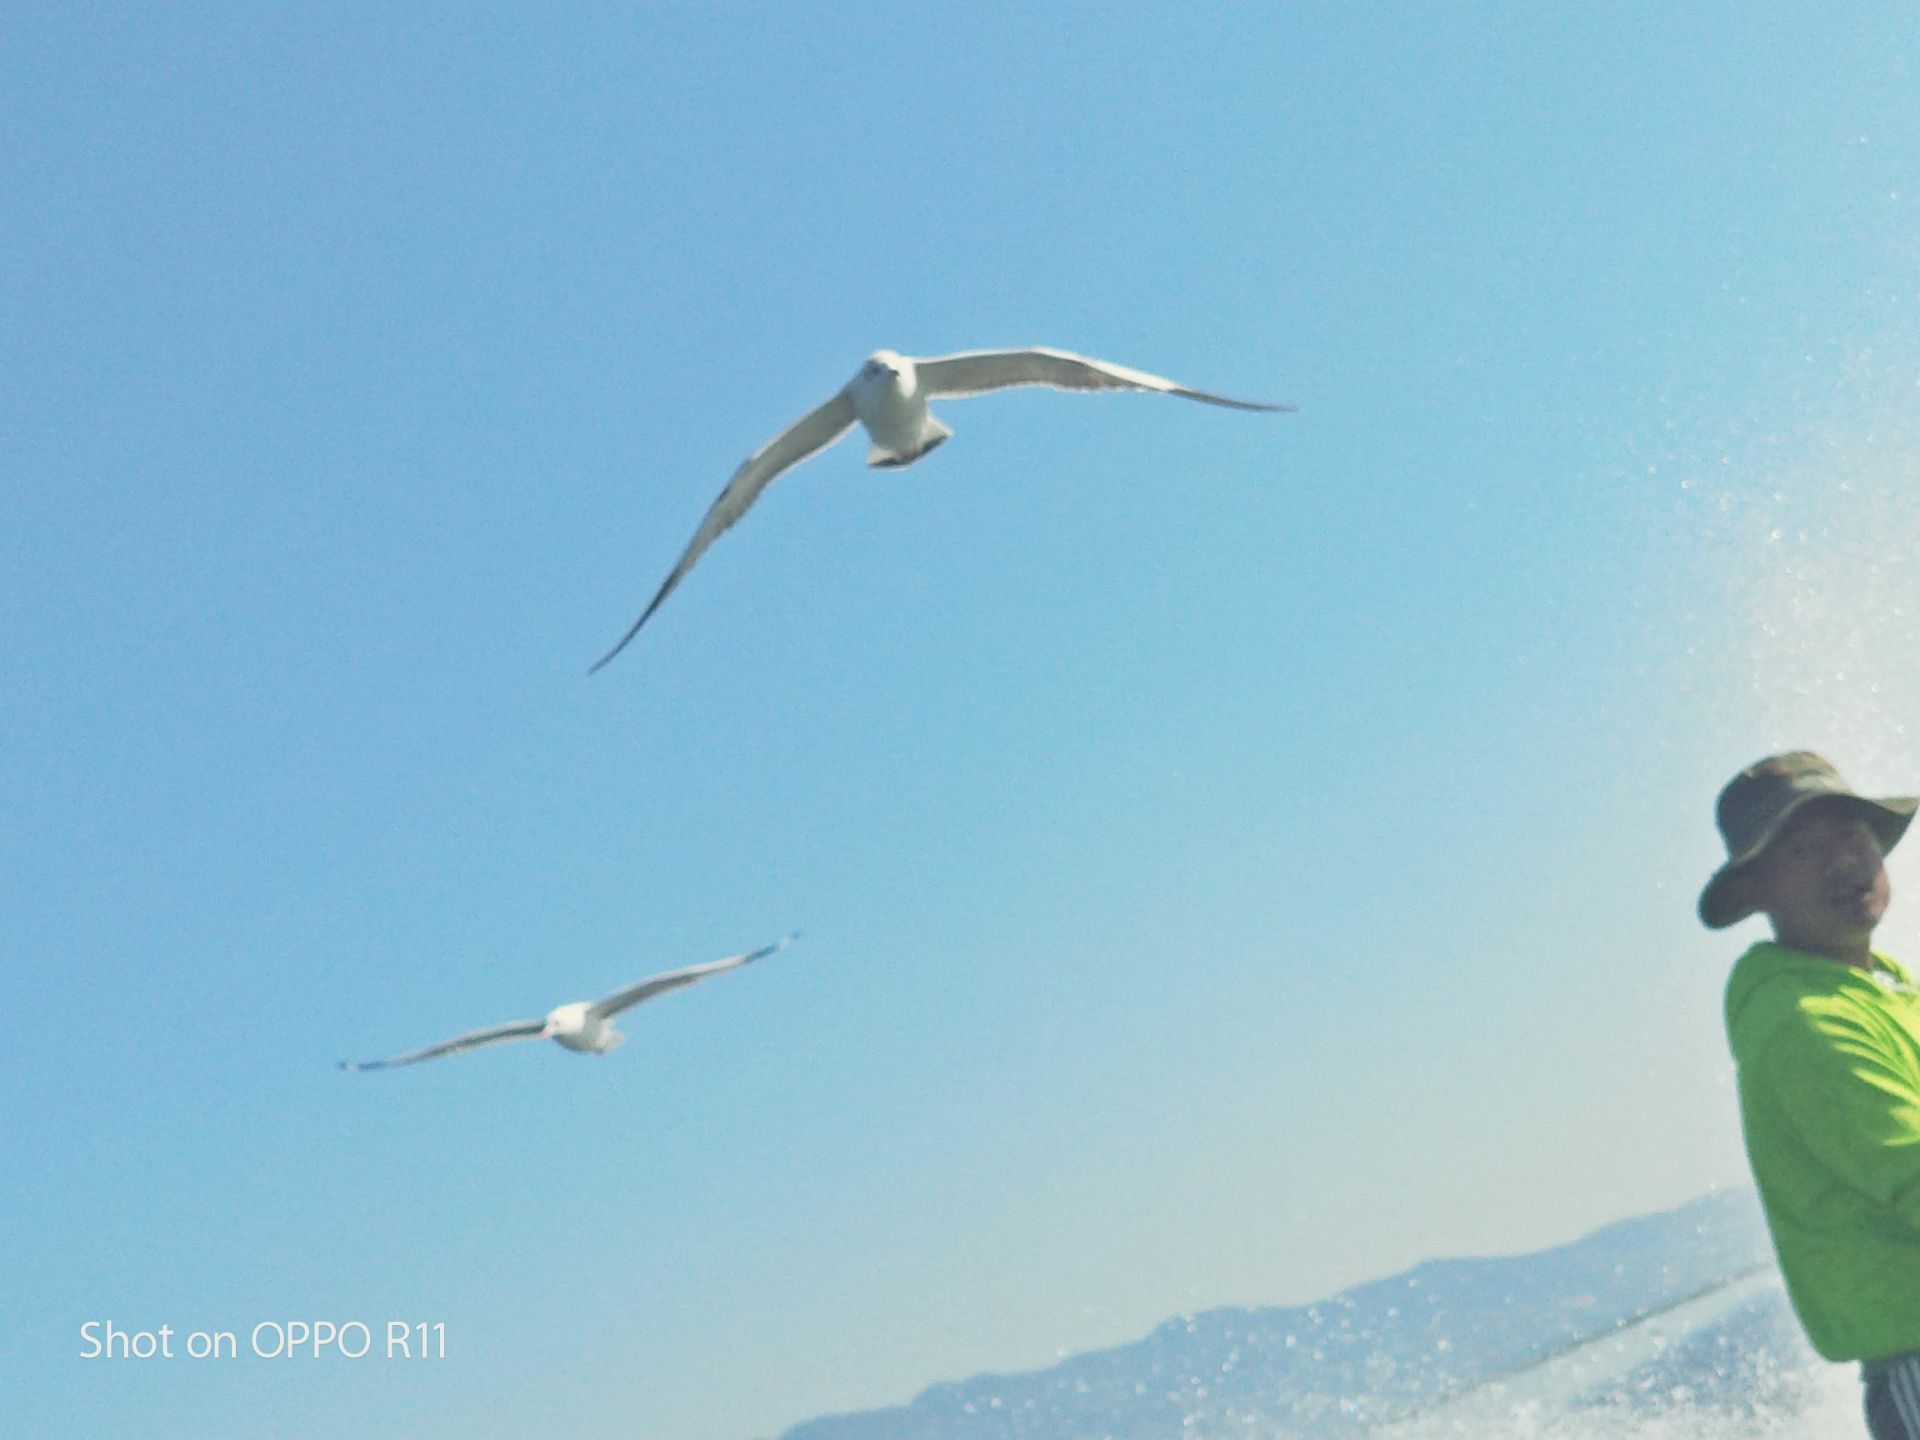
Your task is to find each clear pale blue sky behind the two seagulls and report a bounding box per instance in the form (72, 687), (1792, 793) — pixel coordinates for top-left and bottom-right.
(11, 4), (1920, 1440)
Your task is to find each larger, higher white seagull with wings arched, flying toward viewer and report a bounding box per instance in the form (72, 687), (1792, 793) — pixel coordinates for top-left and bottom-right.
(589, 346), (1294, 674)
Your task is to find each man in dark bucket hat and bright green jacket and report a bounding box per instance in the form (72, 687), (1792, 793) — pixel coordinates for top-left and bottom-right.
(1699, 751), (1920, 1440)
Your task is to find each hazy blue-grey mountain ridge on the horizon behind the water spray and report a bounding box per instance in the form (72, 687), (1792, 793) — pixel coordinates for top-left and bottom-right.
(781, 1190), (1820, 1440)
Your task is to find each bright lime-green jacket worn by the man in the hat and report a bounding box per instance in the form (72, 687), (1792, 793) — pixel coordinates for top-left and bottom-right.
(1726, 943), (1920, 1359)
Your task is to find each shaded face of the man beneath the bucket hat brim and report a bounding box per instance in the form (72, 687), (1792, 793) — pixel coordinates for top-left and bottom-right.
(1749, 801), (1889, 958)
